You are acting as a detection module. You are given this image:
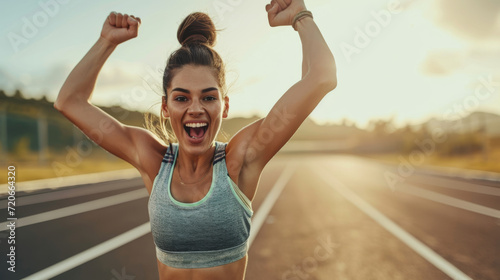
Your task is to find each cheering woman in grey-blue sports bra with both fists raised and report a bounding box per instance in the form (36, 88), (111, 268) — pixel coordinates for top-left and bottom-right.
(54, 0), (337, 279)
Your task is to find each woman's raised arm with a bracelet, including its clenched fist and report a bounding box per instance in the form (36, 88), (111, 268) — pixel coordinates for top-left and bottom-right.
(232, 0), (337, 169)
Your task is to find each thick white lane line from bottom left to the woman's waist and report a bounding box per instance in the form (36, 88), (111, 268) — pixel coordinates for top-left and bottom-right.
(22, 222), (151, 280)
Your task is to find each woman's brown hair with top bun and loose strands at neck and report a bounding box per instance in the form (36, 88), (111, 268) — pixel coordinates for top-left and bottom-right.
(146, 12), (227, 143)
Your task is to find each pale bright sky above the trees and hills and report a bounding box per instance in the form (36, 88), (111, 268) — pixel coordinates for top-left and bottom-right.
(0, 0), (500, 127)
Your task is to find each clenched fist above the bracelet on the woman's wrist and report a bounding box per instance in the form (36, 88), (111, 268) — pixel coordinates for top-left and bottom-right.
(266, 0), (307, 27)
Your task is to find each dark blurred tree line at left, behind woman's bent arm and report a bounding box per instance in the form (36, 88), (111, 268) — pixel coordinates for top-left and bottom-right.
(0, 90), (144, 164)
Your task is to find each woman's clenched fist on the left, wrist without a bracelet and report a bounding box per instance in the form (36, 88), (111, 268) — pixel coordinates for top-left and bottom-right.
(101, 12), (141, 45)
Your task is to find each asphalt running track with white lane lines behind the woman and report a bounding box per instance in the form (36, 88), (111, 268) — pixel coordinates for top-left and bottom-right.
(0, 153), (500, 280)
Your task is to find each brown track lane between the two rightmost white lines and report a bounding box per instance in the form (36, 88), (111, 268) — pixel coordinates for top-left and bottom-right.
(322, 157), (500, 279)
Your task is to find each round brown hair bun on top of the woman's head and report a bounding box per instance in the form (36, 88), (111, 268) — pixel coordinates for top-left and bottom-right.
(177, 12), (217, 47)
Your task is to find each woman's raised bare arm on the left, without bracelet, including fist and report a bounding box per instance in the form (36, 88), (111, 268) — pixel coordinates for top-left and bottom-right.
(54, 13), (162, 169)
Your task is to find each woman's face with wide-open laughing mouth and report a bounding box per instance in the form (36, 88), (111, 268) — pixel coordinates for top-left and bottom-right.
(162, 65), (229, 154)
